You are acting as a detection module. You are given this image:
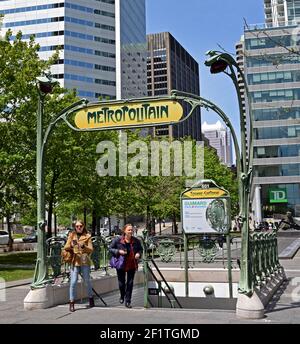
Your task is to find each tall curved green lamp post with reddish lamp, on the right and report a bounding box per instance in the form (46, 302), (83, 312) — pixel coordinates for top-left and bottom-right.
(205, 50), (253, 296)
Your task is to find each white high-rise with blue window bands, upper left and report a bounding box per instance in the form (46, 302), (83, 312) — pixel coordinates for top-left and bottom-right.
(0, 0), (146, 99)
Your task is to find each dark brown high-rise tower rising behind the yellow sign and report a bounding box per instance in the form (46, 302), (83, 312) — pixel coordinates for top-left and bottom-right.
(147, 32), (201, 141)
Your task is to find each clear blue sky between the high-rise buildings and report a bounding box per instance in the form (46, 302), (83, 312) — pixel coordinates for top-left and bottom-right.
(146, 0), (264, 142)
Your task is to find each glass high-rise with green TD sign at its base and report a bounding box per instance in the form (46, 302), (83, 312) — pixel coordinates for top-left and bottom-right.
(237, 1), (300, 221)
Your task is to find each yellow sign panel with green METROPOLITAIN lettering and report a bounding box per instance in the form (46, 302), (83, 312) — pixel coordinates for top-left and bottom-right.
(75, 100), (183, 129)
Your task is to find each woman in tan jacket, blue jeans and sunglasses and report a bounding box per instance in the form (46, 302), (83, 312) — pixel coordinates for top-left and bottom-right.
(64, 220), (95, 312)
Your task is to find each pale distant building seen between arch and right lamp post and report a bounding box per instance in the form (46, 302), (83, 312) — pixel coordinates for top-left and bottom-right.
(202, 121), (233, 167)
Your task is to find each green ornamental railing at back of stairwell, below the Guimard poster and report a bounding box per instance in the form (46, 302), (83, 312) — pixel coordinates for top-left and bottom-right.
(140, 231), (240, 308)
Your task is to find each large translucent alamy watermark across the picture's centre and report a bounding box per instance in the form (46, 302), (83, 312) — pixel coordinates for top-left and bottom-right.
(96, 132), (204, 187)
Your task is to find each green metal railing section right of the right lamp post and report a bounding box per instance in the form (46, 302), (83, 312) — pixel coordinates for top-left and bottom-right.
(250, 231), (282, 287)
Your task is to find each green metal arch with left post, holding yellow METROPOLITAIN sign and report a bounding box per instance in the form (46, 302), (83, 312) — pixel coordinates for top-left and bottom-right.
(31, 88), (241, 292)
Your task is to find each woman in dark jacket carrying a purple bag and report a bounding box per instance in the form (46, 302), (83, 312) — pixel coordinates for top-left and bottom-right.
(109, 224), (143, 308)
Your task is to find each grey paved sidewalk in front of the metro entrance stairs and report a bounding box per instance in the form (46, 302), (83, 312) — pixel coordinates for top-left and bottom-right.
(0, 252), (300, 324)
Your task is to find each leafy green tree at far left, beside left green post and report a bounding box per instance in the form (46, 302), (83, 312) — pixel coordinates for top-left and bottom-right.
(0, 31), (52, 246)
